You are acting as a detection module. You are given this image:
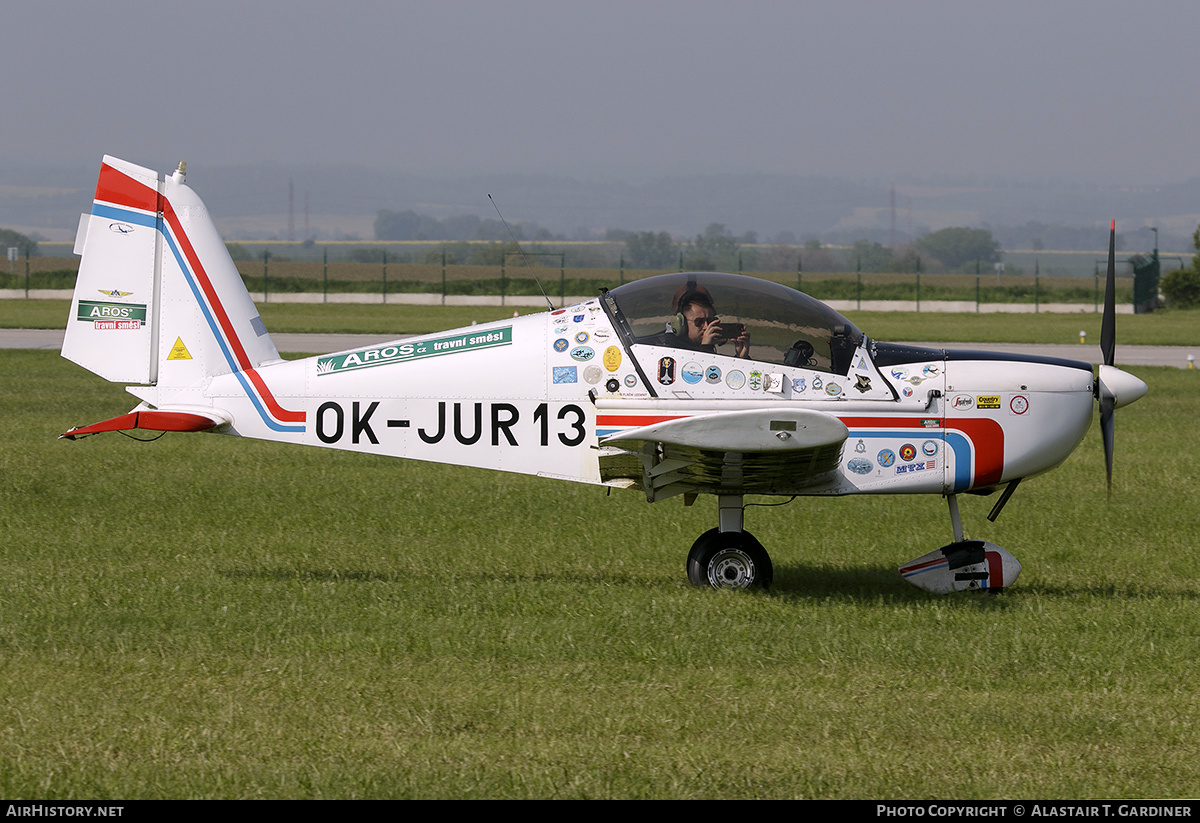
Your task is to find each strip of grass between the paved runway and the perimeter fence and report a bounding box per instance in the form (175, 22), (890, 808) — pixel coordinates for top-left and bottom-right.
(0, 300), (1200, 346)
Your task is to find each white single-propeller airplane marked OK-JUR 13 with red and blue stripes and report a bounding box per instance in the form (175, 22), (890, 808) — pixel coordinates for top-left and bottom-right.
(62, 157), (1146, 593)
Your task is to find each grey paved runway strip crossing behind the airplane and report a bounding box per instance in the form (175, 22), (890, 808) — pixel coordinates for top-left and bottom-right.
(0, 329), (1200, 368)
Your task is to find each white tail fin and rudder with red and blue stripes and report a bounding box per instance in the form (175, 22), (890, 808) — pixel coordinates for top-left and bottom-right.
(62, 156), (280, 403)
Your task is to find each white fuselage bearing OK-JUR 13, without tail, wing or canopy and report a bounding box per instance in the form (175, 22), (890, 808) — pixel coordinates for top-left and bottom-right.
(204, 300), (1093, 494)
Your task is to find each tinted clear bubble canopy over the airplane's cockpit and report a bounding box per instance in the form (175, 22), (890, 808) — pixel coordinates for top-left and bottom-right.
(605, 271), (863, 373)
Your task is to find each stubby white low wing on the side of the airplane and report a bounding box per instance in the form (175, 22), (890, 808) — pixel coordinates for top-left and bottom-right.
(600, 409), (848, 500)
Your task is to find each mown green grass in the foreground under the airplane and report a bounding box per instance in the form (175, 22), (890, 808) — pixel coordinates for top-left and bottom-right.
(0, 350), (1200, 799)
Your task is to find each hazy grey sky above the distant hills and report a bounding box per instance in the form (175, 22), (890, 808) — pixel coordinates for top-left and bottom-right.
(0, 0), (1200, 185)
